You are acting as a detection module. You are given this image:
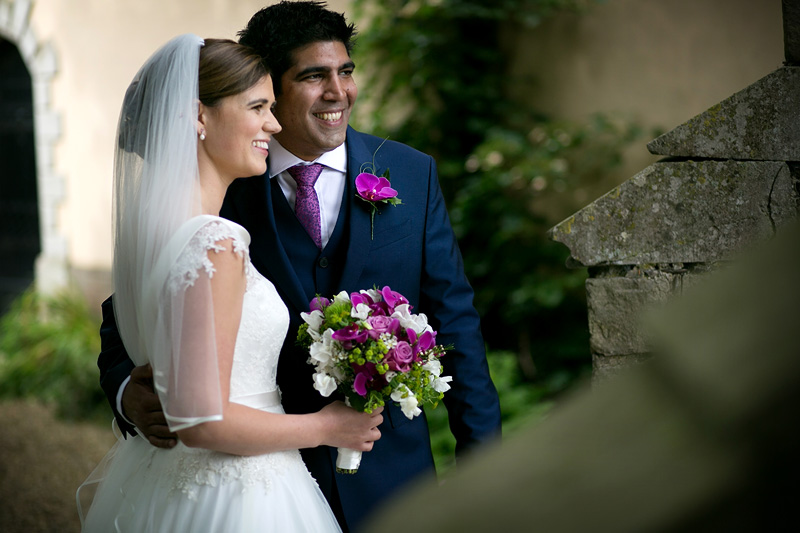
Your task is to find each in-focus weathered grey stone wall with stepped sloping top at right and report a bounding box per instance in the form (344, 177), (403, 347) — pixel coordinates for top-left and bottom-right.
(550, 0), (800, 379)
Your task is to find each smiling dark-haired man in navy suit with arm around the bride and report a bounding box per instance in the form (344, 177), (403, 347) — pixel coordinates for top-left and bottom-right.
(98, 2), (500, 530)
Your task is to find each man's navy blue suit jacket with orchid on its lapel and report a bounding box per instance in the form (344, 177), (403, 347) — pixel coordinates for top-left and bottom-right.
(98, 128), (500, 529)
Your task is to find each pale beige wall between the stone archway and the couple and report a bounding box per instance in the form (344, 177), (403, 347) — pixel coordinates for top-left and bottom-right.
(31, 0), (346, 270)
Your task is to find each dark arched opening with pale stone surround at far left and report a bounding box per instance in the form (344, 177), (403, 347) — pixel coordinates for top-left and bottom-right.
(0, 0), (67, 305)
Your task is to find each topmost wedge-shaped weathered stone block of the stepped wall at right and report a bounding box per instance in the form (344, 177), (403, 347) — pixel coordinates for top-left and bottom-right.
(647, 67), (800, 161)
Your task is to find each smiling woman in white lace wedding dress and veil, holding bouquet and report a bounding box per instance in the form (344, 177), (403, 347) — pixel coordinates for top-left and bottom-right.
(78, 35), (382, 532)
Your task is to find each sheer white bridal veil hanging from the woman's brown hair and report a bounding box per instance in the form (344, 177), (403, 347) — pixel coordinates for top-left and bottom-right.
(112, 34), (222, 431)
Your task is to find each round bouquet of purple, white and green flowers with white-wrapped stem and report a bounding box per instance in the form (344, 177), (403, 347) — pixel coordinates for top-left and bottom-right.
(297, 287), (453, 473)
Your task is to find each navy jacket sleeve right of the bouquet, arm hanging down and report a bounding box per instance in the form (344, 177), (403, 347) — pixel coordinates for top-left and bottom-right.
(420, 154), (501, 455)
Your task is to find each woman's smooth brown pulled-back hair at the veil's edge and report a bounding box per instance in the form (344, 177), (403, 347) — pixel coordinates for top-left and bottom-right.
(199, 39), (269, 107)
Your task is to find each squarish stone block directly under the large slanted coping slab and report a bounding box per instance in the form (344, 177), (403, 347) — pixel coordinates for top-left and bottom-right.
(586, 275), (674, 356)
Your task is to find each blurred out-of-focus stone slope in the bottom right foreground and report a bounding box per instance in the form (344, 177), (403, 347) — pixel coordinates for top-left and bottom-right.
(364, 218), (800, 533)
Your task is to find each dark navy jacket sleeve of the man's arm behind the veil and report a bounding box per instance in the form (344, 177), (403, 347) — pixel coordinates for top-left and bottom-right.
(97, 297), (136, 436)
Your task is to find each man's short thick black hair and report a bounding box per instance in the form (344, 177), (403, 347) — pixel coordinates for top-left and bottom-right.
(238, 0), (356, 96)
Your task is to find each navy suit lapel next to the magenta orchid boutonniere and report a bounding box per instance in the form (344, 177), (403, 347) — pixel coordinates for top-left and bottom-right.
(339, 128), (383, 290)
